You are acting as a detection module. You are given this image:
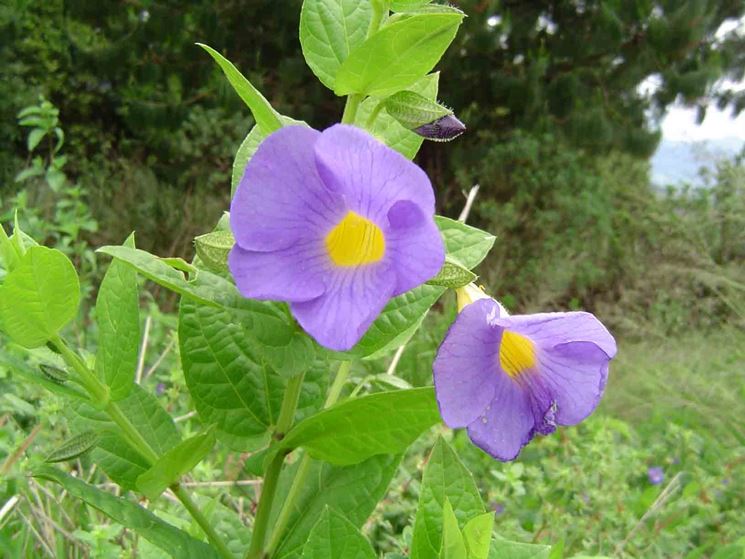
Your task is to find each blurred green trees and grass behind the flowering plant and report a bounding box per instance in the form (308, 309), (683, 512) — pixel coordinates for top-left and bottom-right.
(0, 0), (745, 559)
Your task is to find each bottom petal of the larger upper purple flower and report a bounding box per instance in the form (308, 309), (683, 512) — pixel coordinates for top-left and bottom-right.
(290, 263), (395, 351)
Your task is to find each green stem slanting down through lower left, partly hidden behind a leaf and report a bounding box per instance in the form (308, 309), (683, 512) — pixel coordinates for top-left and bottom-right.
(51, 336), (235, 559)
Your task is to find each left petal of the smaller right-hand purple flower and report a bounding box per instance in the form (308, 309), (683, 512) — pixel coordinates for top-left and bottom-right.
(432, 299), (501, 428)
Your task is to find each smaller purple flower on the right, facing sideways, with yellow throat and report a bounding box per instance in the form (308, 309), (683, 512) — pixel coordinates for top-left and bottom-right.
(434, 290), (616, 460)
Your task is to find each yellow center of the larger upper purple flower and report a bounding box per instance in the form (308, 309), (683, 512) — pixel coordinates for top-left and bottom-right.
(326, 211), (385, 266)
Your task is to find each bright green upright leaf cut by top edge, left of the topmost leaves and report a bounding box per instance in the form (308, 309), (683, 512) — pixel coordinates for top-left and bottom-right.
(300, 0), (372, 90)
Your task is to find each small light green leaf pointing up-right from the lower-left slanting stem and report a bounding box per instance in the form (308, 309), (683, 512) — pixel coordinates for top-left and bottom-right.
(137, 427), (215, 501)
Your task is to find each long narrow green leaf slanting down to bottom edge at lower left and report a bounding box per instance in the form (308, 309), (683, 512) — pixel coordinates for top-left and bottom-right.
(34, 466), (219, 559)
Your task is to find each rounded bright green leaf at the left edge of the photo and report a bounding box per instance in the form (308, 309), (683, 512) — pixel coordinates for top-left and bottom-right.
(0, 246), (80, 348)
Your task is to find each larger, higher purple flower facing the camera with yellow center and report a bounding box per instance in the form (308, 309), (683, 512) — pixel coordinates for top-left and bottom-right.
(228, 125), (445, 351)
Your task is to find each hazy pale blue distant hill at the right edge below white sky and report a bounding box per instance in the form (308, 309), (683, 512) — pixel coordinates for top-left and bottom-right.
(652, 136), (745, 186)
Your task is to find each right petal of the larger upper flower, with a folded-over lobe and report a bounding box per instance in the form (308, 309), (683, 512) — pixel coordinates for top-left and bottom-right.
(386, 200), (445, 296)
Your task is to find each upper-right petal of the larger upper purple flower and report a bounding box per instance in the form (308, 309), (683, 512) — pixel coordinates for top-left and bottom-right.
(315, 124), (435, 223)
